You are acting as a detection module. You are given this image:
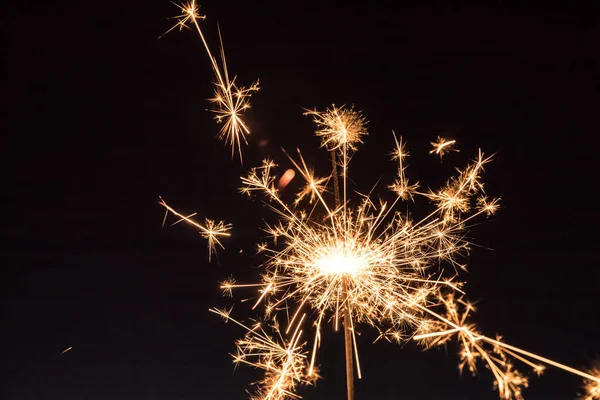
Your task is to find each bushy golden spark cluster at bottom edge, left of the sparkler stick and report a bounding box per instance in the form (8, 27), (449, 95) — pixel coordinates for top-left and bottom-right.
(210, 308), (316, 400)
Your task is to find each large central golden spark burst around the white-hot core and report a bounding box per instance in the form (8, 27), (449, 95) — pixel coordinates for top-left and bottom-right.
(223, 111), (490, 382)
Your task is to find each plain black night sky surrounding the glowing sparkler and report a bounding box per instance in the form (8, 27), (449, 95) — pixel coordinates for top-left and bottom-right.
(0, 0), (600, 400)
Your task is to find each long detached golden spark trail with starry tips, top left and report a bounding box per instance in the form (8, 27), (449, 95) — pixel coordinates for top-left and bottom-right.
(163, 0), (260, 162)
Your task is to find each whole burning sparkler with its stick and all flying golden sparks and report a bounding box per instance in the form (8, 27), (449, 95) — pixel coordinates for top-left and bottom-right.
(161, 1), (600, 400)
